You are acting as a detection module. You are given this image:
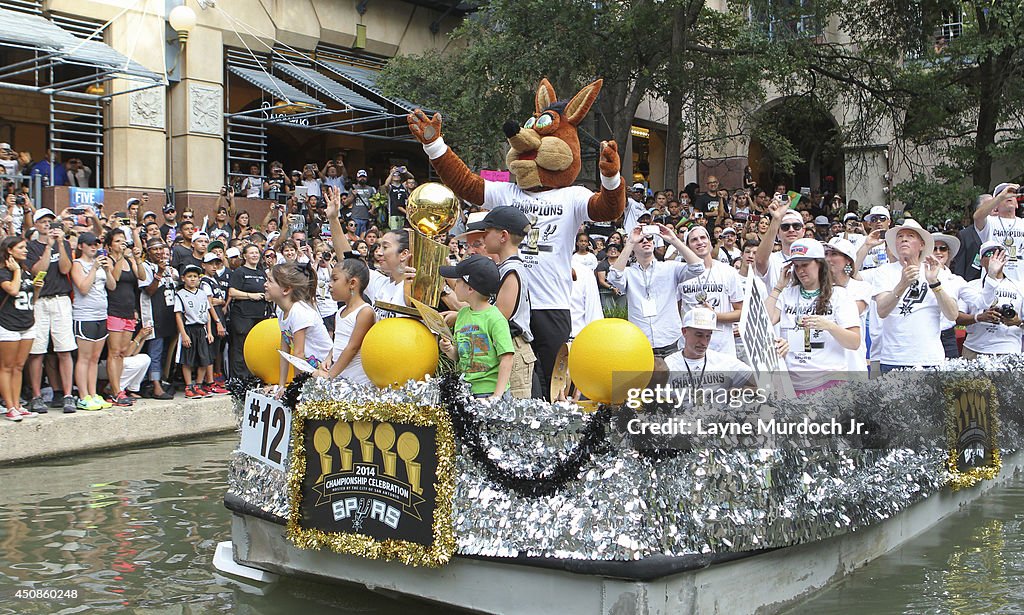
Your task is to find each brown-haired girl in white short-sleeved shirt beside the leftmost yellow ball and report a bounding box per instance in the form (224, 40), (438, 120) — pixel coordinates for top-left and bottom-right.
(265, 263), (331, 388)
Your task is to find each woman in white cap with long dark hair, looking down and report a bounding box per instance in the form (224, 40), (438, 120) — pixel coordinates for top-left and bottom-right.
(765, 239), (860, 395)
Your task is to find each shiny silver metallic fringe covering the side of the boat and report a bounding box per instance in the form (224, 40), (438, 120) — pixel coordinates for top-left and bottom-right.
(229, 357), (1024, 560)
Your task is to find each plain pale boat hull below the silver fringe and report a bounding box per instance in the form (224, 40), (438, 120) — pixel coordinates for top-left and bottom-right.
(231, 452), (1024, 615)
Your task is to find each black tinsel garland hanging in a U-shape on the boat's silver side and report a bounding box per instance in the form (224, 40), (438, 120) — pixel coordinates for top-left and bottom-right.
(440, 374), (614, 497)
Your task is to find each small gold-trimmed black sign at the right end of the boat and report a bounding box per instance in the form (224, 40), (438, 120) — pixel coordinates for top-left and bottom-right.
(942, 378), (1002, 491)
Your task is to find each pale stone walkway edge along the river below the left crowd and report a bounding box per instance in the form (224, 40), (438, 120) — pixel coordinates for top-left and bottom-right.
(0, 395), (238, 465)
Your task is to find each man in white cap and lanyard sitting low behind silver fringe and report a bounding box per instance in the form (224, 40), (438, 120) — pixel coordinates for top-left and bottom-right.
(665, 308), (754, 391)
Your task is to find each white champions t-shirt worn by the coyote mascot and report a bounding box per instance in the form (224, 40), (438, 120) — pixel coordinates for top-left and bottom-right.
(481, 181), (594, 310)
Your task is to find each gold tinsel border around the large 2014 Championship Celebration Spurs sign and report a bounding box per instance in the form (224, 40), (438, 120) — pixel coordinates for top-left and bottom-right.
(287, 400), (457, 567)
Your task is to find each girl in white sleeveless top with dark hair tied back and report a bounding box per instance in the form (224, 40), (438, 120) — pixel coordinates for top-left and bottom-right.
(313, 259), (377, 385)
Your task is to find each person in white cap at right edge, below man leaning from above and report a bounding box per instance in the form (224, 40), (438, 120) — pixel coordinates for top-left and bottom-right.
(964, 240), (1024, 359)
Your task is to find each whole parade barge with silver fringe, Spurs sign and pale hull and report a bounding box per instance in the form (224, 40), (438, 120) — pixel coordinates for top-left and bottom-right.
(218, 347), (1024, 614)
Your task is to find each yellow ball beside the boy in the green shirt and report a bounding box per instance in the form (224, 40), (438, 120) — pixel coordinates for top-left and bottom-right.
(359, 318), (437, 389)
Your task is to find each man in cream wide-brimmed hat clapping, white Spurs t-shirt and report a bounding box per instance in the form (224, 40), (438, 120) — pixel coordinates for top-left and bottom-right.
(871, 220), (959, 374)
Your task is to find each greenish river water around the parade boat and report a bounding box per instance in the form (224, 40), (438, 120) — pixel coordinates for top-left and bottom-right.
(0, 435), (1024, 615)
